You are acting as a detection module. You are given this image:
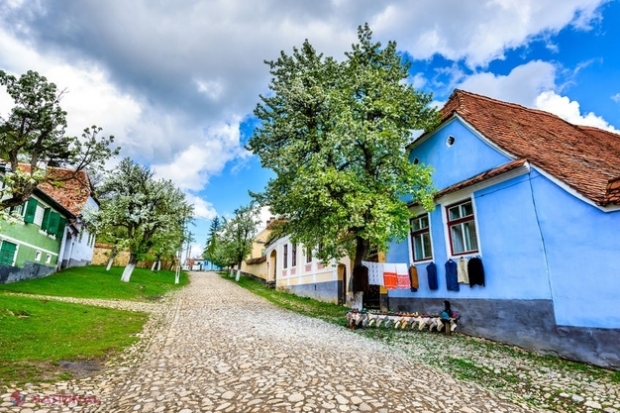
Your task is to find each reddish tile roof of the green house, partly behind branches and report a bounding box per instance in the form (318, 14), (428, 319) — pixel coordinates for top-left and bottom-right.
(19, 164), (91, 217)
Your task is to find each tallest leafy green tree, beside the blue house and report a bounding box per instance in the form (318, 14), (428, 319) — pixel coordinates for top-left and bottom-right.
(248, 25), (438, 272)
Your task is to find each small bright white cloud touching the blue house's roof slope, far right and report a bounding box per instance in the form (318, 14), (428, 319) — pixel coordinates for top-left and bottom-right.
(536, 91), (620, 132)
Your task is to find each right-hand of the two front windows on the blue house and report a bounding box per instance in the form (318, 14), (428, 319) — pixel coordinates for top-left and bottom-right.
(446, 199), (478, 255)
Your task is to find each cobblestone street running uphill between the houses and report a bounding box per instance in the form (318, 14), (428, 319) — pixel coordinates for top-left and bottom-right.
(0, 273), (535, 413)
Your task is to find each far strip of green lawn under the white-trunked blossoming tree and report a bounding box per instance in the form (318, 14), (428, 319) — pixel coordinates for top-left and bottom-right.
(0, 266), (188, 301)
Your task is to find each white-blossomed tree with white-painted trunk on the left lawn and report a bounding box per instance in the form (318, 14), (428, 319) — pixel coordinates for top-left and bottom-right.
(85, 158), (193, 281)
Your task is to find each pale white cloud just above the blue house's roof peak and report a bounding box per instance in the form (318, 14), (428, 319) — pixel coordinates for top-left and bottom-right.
(457, 60), (556, 107)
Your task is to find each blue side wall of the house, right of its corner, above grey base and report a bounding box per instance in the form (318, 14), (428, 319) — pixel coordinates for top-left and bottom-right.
(532, 169), (620, 328)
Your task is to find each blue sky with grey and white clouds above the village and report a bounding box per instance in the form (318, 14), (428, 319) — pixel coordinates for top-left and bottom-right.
(0, 0), (620, 256)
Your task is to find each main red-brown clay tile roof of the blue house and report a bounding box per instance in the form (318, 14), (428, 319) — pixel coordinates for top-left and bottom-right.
(441, 89), (620, 205)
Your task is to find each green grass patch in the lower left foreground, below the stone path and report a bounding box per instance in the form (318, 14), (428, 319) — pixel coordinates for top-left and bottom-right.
(0, 294), (148, 385)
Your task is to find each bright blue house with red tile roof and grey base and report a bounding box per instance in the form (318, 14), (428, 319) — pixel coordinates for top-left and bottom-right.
(387, 90), (620, 368)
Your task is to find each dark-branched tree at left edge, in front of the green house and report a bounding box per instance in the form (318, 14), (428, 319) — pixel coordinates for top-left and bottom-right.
(0, 70), (119, 212)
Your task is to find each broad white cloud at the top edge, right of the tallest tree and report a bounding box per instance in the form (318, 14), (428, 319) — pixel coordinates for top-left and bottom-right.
(370, 0), (605, 67)
